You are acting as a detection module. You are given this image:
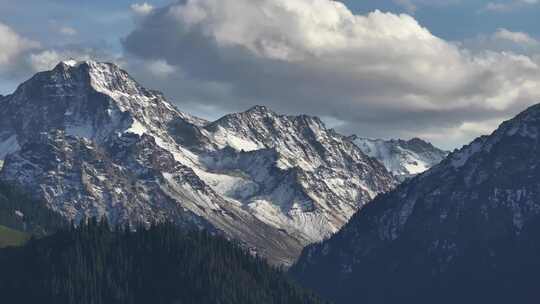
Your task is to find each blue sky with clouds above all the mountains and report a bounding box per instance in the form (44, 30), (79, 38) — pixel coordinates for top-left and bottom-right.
(0, 0), (540, 149)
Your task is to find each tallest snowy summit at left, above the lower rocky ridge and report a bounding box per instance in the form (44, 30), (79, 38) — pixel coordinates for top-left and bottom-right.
(0, 60), (190, 145)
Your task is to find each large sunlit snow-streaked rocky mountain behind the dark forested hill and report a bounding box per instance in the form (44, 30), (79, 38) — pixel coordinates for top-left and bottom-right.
(0, 61), (396, 264)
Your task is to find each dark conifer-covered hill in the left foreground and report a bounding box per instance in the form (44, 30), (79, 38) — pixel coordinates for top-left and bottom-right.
(0, 221), (330, 304)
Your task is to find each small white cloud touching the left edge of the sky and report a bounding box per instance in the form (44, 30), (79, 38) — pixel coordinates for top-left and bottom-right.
(0, 23), (39, 68)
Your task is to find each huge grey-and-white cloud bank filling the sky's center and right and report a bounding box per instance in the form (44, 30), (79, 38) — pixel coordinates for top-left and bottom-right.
(124, 0), (540, 147)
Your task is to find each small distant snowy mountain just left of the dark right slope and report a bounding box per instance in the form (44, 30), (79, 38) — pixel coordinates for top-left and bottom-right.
(354, 138), (448, 180)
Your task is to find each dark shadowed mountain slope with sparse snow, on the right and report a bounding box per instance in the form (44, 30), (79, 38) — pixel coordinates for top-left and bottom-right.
(291, 105), (540, 303)
